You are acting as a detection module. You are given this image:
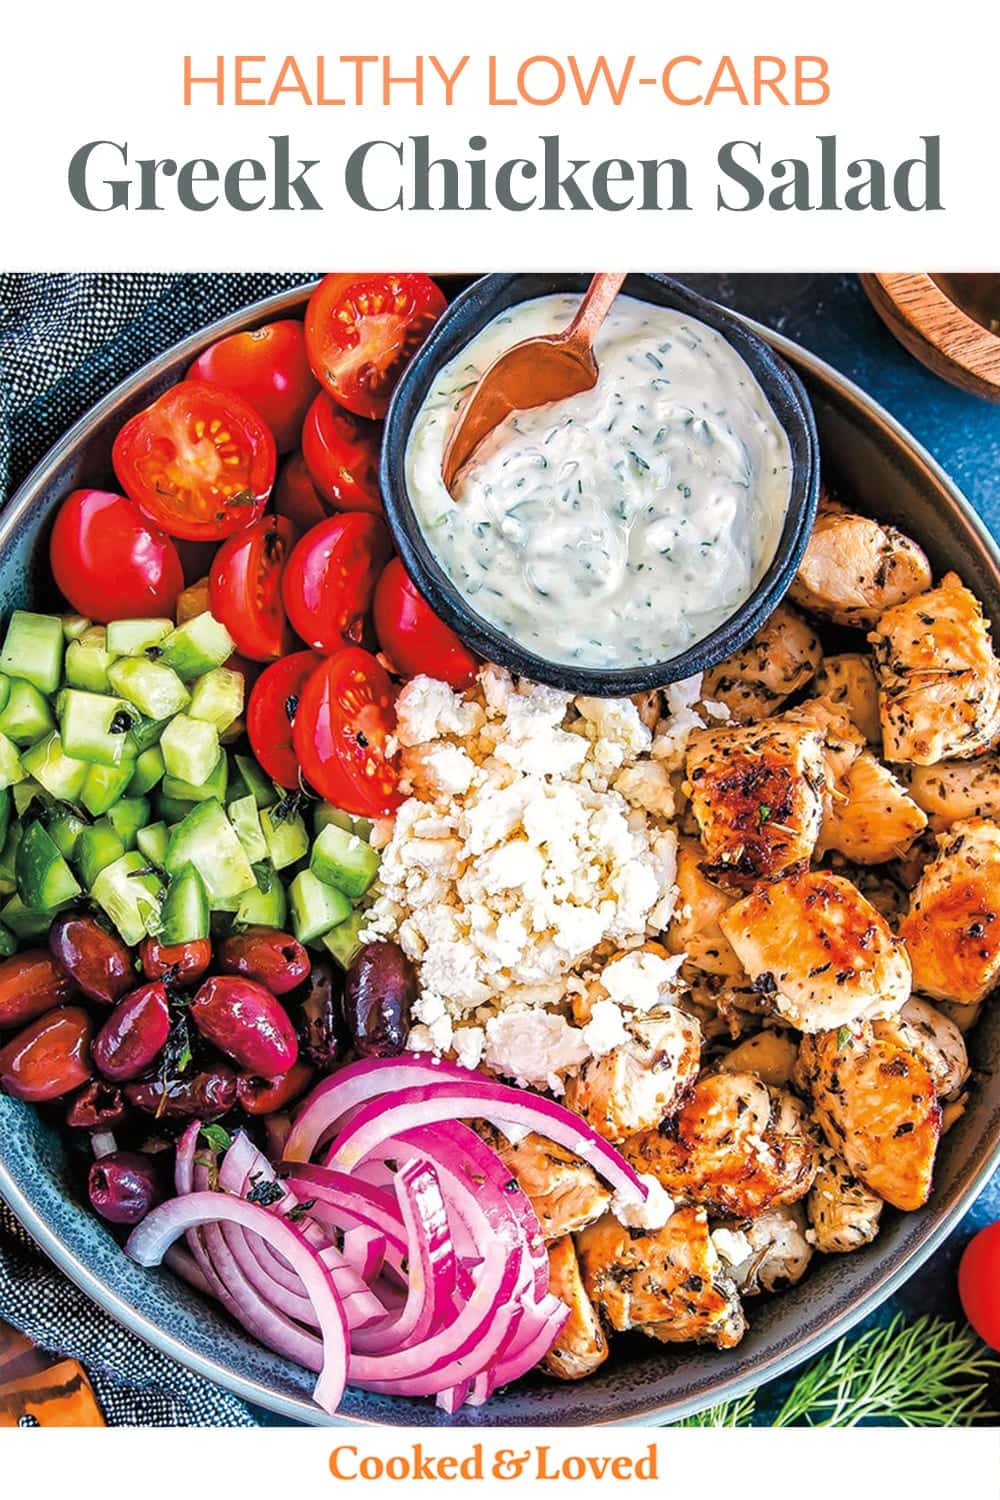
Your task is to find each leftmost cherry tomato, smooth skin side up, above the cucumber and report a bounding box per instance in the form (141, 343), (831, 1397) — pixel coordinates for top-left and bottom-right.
(49, 489), (184, 624)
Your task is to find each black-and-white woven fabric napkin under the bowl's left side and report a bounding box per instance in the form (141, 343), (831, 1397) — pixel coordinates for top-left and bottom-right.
(0, 273), (309, 1427)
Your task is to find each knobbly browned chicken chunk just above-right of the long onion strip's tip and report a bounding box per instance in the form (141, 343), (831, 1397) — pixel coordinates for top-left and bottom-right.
(622, 1073), (816, 1218)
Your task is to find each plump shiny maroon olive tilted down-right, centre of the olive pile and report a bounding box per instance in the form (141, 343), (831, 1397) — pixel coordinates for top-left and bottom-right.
(190, 974), (298, 1079)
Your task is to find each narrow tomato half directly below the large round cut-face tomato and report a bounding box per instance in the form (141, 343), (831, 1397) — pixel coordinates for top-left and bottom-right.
(208, 516), (298, 662)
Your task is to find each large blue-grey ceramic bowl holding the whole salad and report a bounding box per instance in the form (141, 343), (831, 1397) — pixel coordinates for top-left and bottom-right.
(0, 283), (1000, 1427)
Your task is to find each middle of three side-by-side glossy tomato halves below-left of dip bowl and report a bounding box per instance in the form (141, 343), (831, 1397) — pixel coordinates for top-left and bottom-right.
(282, 512), (393, 654)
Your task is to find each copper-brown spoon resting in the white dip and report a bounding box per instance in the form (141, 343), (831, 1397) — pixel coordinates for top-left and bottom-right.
(441, 272), (627, 498)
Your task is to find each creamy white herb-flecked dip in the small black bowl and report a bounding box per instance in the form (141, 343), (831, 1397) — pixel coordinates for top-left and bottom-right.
(406, 296), (792, 668)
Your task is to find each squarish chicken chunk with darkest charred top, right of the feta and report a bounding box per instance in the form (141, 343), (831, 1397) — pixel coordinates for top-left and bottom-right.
(685, 719), (823, 890)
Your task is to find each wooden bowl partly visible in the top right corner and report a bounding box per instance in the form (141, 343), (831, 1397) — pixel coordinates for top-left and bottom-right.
(861, 272), (1000, 402)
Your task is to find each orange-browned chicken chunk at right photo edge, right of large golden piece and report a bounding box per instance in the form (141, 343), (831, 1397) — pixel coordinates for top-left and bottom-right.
(900, 818), (1000, 1005)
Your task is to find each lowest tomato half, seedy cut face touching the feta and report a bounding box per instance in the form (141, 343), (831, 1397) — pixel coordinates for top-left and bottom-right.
(290, 647), (402, 818)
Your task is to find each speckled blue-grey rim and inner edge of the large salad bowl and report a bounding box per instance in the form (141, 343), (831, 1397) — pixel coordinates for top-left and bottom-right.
(0, 287), (1000, 1427)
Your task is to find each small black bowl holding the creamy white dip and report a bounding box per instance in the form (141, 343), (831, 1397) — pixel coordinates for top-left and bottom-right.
(381, 272), (820, 698)
